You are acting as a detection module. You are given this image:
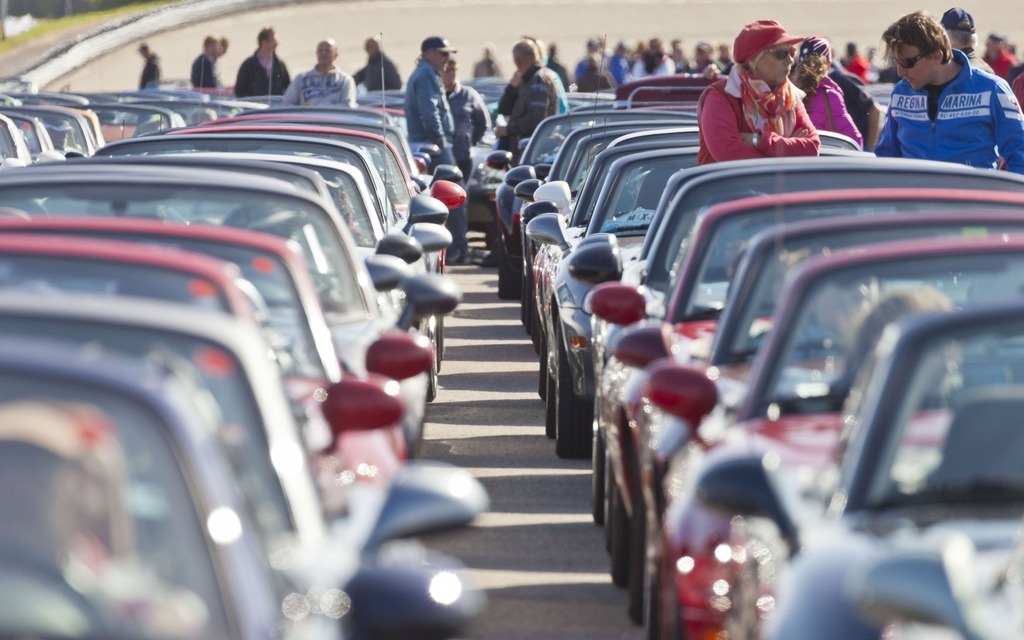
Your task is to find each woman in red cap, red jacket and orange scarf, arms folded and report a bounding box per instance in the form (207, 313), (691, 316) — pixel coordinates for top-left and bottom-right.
(697, 19), (819, 165)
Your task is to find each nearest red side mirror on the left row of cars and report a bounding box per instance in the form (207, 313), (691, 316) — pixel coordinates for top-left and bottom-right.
(321, 374), (406, 437)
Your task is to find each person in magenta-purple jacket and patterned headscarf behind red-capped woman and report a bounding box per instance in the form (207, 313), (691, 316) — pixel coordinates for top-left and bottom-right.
(791, 36), (864, 146)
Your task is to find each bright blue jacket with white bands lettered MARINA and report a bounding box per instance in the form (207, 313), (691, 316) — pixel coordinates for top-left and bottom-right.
(874, 49), (1024, 173)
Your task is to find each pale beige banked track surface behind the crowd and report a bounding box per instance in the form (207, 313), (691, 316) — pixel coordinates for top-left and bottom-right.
(43, 0), (1024, 91)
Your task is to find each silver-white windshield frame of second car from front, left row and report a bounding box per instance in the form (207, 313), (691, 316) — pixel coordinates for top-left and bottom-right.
(0, 291), (326, 540)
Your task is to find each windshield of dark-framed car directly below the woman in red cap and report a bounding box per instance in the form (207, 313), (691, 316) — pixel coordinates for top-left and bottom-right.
(646, 167), (1021, 293)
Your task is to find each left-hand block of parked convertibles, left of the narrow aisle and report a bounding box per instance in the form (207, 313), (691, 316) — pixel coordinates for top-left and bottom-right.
(0, 86), (488, 640)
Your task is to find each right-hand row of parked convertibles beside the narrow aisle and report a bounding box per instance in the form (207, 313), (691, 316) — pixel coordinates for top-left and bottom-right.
(497, 72), (1024, 639)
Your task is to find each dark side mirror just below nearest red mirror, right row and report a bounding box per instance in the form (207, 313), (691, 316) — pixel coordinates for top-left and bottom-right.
(694, 454), (800, 555)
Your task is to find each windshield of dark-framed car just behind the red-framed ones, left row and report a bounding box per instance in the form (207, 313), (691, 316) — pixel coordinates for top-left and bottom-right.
(0, 181), (368, 314)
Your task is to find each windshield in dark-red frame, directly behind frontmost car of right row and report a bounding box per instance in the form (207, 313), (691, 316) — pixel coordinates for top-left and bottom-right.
(752, 253), (1024, 418)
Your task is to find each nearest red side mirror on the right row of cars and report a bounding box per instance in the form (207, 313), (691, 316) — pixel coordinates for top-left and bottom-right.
(643, 359), (718, 430)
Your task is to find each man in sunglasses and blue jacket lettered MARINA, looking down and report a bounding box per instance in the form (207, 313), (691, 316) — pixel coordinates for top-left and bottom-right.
(874, 11), (1024, 173)
